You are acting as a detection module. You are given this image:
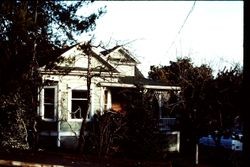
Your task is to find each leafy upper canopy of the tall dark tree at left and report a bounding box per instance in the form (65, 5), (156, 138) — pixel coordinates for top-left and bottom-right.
(0, 0), (104, 92)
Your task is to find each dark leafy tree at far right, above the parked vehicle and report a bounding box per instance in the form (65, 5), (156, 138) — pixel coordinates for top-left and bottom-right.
(210, 65), (243, 130)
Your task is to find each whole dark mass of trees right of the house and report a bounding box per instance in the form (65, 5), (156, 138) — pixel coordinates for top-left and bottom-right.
(149, 58), (242, 153)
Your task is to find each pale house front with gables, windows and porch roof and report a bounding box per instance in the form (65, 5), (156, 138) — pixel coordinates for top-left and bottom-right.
(38, 44), (180, 148)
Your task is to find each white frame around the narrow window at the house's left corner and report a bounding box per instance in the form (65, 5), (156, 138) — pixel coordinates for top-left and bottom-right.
(40, 85), (58, 122)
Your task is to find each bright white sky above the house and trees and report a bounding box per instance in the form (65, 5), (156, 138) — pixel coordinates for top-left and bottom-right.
(75, 1), (244, 77)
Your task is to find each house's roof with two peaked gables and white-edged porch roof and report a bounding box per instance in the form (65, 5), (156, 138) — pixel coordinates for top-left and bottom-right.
(39, 43), (180, 90)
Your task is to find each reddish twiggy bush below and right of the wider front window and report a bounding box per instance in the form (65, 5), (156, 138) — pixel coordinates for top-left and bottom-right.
(84, 111), (126, 156)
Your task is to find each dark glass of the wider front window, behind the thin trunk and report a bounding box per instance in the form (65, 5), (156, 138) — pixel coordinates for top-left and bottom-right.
(70, 90), (88, 119)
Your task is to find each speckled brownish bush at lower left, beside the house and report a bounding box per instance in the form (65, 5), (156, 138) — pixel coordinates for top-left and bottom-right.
(0, 95), (29, 151)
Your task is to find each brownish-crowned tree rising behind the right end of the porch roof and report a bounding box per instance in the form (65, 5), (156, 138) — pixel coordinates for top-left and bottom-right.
(149, 58), (213, 150)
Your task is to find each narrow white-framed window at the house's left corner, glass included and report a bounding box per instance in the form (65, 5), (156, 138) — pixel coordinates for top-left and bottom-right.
(41, 86), (56, 121)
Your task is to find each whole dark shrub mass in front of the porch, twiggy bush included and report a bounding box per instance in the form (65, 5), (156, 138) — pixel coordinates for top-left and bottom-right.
(85, 89), (168, 159)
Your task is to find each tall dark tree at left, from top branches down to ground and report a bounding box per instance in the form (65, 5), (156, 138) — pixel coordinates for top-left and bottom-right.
(0, 0), (104, 151)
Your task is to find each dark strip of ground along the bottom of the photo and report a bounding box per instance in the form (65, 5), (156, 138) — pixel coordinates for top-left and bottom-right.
(0, 148), (243, 167)
